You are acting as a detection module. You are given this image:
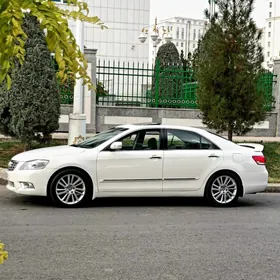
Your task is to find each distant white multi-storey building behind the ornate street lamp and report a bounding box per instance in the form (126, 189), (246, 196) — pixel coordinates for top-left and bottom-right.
(150, 17), (206, 64)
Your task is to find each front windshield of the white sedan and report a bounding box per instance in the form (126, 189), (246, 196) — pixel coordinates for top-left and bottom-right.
(72, 127), (127, 149)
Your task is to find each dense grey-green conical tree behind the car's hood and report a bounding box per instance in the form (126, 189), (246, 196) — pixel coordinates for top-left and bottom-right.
(0, 15), (60, 147)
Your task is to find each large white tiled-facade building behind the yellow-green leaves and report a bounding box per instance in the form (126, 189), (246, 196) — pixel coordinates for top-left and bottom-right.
(54, 0), (150, 63)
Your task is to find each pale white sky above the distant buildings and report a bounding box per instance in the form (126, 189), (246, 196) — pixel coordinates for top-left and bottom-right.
(150, 0), (268, 28)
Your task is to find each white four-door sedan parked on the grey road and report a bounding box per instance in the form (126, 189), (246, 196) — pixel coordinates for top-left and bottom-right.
(7, 124), (268, 207)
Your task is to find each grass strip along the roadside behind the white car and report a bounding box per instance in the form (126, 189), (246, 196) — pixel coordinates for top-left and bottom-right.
(0, 140), (280, 183)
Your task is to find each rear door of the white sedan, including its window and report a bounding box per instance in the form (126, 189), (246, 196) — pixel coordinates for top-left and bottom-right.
(163, 129), (223, 192)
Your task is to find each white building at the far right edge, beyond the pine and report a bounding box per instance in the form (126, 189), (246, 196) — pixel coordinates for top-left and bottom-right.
(263, 0), (280, 65)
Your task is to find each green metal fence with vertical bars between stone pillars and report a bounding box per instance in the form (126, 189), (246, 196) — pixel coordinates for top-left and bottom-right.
(61, 61), (275, 111)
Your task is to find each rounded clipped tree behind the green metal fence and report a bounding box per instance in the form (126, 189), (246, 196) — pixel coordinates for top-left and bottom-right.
(152, 42), (183, 104)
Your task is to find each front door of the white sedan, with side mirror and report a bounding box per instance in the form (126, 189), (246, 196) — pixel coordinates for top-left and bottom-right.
(97, 129), (163, 192)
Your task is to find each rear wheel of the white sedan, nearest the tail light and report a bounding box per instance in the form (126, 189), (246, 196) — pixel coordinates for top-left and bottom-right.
(205, 171), (242, 207)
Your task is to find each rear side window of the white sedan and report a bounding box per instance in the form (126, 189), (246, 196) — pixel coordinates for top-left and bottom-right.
(167, 129), (218, 150)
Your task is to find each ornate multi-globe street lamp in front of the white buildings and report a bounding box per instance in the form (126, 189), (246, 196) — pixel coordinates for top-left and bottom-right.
(138, 18), (173, 64)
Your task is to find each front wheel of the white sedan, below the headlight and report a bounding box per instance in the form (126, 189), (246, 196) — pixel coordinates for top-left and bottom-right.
(49, 168), (93, 208)
